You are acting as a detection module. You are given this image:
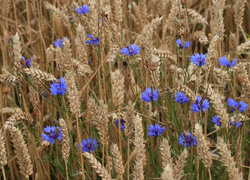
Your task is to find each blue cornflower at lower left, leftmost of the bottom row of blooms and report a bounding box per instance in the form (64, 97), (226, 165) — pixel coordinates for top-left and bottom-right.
(42, 126), (62, 144)
